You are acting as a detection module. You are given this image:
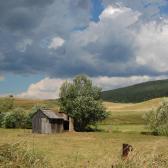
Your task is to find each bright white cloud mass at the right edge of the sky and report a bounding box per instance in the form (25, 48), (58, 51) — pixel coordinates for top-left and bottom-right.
(136, 20), (168, 72)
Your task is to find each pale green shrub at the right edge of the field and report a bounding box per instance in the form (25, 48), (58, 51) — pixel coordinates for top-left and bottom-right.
(144, 101), (168, 136)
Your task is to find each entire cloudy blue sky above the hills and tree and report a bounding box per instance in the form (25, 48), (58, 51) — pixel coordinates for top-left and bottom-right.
(0, 0), (168, 99)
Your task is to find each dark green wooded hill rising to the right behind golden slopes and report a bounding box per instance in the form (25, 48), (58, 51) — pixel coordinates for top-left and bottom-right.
(101, 79), (168, 103)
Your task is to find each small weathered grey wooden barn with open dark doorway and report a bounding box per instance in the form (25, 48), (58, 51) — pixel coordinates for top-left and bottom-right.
(32, 109), (73, 134)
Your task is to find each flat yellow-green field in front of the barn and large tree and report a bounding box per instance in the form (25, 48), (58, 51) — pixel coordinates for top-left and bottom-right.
(0, 129), (168, 168)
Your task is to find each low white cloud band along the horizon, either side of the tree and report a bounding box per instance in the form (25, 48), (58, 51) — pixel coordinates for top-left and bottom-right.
(17, 76), (168, 99)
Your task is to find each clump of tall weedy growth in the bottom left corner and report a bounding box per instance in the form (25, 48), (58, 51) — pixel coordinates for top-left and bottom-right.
(0, 143), (51, 168)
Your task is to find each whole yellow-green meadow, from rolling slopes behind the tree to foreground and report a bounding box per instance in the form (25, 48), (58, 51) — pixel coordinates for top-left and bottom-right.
(0, 99), (168, 168)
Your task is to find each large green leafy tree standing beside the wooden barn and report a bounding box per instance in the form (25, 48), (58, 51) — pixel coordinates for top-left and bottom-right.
(60, 75), (107, 131)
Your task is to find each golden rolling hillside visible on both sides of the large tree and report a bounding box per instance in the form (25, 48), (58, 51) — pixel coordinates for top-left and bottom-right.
(14, 98), (162, 125)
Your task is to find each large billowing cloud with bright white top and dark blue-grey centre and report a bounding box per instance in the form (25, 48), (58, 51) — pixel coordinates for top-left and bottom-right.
(63, 6), (140, 76)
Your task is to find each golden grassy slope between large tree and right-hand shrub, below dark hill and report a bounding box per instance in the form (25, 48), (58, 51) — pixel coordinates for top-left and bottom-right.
(102, 98), (166, 125)
